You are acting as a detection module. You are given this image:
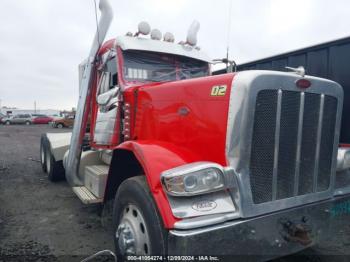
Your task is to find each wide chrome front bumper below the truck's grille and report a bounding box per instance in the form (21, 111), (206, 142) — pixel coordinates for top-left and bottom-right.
(168, 195), (350, 260)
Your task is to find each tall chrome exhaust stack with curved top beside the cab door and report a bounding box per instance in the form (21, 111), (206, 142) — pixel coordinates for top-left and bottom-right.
(65, 0), (113, 187)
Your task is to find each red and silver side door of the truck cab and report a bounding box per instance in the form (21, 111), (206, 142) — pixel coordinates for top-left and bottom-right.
(93, 51), (121, 146)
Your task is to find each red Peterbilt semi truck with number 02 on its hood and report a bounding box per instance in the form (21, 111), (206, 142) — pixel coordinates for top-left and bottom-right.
(41, 0), (350, 259)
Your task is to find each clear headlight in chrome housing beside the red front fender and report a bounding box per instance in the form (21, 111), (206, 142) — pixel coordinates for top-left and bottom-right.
(161, 162), (225, 196)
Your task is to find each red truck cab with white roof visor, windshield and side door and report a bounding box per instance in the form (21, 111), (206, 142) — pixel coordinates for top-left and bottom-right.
(90, 36), (210, 149)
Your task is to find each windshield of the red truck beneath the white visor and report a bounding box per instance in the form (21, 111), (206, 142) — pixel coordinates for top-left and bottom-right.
(123, 50), (209, 82)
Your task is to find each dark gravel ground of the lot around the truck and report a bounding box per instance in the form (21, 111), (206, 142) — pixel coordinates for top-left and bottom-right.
(0, 125), (350, 262)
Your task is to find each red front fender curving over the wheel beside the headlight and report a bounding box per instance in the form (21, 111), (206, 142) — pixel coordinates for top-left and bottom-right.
(116, 141), (201, 229)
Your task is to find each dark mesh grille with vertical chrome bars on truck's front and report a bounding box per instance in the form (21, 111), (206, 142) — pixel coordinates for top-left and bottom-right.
(250, 90), (338, 204)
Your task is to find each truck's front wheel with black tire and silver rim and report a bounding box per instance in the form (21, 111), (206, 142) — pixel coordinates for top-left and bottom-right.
(113, 176), (167, 256)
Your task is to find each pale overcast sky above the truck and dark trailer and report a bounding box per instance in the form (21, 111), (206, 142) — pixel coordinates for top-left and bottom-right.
(0, 0), (350, 109)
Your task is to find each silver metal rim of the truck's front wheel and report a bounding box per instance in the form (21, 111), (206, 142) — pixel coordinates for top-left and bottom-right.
(115, 204), (151, 255)
